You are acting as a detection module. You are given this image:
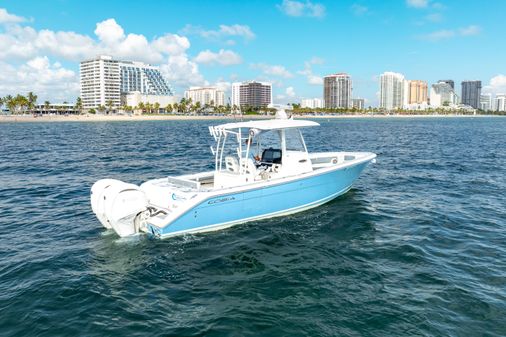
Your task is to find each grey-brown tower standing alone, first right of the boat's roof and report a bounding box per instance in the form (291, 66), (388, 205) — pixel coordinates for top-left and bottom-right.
(323, 73), (352, 109)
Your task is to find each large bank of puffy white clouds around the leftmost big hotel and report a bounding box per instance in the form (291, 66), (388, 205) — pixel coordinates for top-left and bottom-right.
(0, 10), (210, 101)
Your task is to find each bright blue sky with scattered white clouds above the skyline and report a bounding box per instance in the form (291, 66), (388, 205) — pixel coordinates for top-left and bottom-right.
(0, 0), (506, 106)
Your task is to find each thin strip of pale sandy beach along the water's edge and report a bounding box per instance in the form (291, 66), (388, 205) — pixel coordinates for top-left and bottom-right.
(0, 115), (501, 123)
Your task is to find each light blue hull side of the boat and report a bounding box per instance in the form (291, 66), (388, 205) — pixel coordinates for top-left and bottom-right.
(147, 160), (371, 238)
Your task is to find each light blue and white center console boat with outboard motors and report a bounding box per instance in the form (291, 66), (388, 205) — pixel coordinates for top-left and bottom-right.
(90, 110), (376, 238)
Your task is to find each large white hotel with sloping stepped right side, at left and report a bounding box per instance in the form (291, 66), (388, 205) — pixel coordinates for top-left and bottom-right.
(79, 55), (172, 109)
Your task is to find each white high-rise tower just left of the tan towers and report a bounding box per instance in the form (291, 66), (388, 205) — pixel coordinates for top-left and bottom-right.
(380, 71), (406, 110)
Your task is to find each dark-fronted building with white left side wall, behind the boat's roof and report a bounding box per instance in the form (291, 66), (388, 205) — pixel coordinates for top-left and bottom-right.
(231, 81), (272, 108)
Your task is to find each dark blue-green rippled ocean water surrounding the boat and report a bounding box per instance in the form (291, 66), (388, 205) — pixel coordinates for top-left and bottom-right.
(0, 118), (506, 336)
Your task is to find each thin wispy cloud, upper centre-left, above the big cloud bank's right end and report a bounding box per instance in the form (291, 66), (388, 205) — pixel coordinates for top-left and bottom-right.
(181, 24), (255, 45)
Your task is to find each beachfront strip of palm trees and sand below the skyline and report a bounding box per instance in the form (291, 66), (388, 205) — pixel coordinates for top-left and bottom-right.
(0, 92), (506, 122)
